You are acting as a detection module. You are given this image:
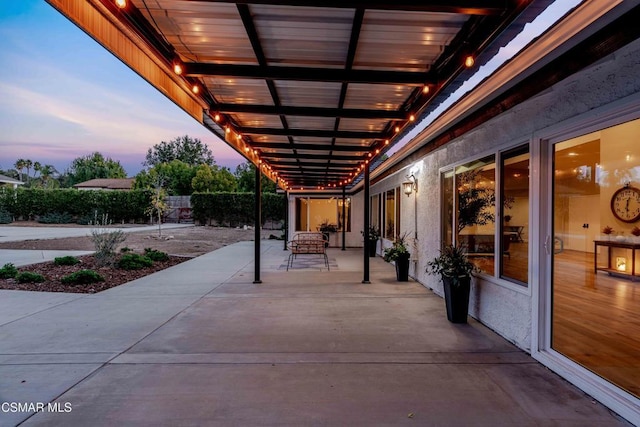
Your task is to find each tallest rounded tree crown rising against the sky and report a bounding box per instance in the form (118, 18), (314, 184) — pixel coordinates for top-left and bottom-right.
(142, 135), (216, 167)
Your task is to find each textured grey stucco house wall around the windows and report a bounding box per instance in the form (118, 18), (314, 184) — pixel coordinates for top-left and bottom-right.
(371, 36), (640, 350)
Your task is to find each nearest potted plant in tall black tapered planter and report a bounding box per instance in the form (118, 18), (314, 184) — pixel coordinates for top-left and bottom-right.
(427, 245), (478, 323)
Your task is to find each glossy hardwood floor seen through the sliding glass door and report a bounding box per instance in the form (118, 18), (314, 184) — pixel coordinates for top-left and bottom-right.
(552, 251), (640, 397)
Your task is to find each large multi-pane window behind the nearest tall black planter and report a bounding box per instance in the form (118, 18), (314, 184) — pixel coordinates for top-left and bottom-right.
(441, 145), (530, 285)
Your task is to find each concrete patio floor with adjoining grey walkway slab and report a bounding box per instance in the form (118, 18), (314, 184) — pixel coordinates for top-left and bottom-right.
(0, 241), (628, 426)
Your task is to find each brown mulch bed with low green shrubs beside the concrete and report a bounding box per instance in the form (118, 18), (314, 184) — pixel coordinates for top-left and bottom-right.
(0, 255), (190, 294)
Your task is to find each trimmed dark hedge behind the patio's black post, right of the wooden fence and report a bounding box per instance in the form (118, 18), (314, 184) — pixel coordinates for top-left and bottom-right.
(191, 193), (286, 226)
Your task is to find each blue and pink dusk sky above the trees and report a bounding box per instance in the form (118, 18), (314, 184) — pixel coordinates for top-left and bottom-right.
(0, 0), (244, 176)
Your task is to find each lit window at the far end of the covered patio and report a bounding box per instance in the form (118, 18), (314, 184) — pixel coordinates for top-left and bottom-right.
(295, 197), (351, 231)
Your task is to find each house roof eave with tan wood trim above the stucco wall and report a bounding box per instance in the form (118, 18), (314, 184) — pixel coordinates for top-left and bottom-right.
(364, 0), (640, 187)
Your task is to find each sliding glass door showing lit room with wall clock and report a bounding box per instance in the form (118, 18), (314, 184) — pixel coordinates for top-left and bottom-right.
(546, 120), (640, 397)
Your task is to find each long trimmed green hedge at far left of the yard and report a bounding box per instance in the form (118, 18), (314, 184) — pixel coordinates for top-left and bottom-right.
(0, 188), (151, 222)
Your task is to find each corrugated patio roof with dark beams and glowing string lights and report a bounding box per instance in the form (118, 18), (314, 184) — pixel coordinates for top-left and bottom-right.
(49, 0), (551, 189)
